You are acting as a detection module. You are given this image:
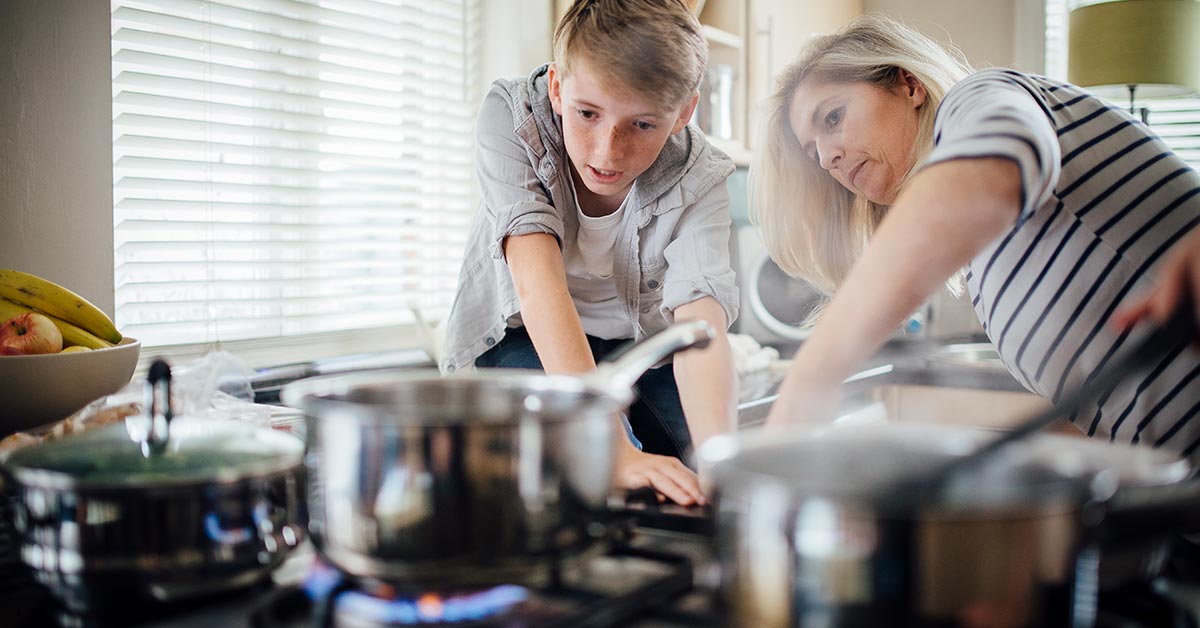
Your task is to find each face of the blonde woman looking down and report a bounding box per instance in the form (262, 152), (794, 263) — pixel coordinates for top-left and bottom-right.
(787, 72), (925, 205)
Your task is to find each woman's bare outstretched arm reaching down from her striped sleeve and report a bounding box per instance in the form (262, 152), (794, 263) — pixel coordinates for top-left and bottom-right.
(767, 157), (1021, 426)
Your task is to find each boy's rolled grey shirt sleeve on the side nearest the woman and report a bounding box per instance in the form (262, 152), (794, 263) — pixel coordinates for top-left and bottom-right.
(661, 181), (739, 324)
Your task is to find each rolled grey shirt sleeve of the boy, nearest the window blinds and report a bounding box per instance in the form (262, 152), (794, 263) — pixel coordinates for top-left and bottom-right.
(475, 85), (563, 259)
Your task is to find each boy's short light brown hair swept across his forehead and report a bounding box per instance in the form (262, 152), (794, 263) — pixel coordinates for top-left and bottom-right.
(554, 0), (708, 108)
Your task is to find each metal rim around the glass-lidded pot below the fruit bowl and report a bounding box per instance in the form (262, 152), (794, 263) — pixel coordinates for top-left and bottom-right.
(0, 418), (305, 492)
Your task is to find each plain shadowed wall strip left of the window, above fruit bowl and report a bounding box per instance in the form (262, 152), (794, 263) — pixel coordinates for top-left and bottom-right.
(0, 0), (113, 315)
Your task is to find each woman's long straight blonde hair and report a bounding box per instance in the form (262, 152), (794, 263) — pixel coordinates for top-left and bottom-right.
(750, 14), (972, 295)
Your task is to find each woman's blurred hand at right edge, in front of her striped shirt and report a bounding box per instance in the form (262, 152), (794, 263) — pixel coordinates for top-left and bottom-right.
(1112, 228), (1200, 330)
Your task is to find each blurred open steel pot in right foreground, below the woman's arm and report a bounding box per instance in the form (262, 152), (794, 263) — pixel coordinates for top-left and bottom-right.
(701, 424), (1200, 627)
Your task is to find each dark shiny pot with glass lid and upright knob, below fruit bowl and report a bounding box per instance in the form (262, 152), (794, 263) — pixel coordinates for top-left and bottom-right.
(0, 361), (305, 621)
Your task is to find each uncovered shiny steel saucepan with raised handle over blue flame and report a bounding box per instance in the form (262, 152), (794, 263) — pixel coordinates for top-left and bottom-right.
(282, 322), (713, 586)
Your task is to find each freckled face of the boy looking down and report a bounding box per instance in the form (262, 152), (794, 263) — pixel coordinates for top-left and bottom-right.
(548, 62), (696, 209)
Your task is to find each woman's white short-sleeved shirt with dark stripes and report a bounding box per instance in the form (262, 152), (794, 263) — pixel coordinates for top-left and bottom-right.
(925, 70), (1200, 462)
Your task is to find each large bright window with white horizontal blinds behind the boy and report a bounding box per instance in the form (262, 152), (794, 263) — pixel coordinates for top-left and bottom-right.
(112, 0), (480, 361)
